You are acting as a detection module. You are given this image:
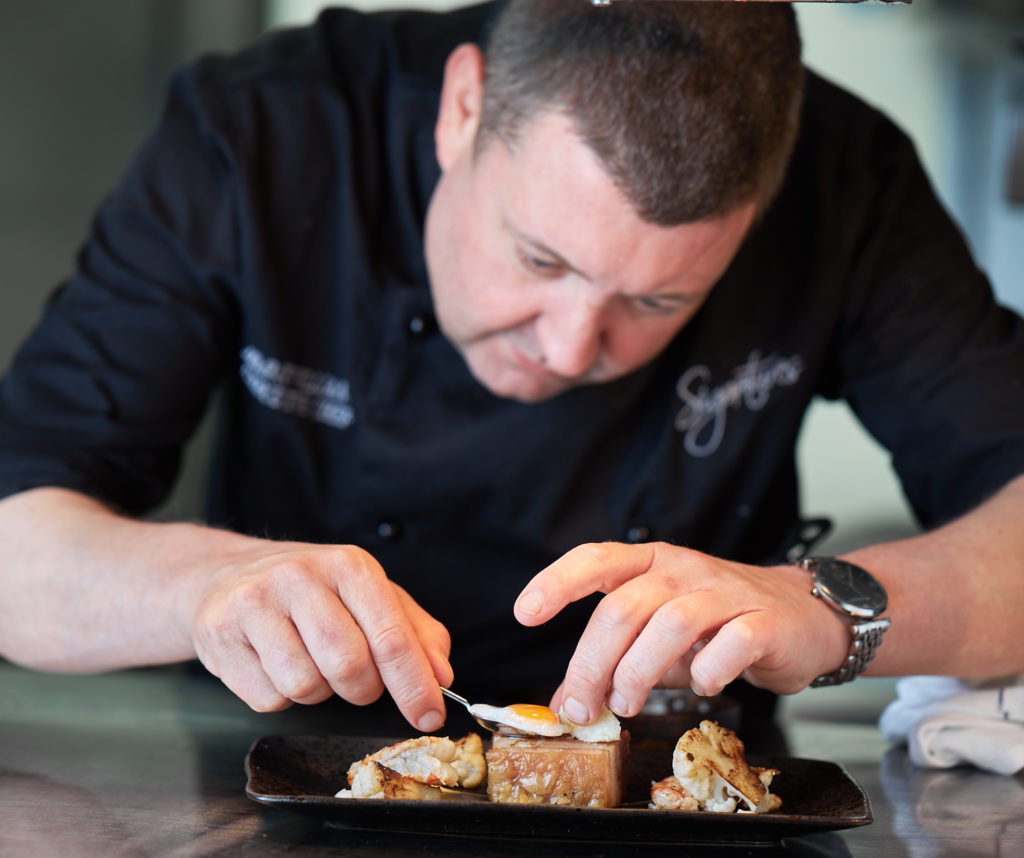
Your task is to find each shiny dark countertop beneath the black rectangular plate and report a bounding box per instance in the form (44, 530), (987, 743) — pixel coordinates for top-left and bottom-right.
(0, 662), (1024, 858)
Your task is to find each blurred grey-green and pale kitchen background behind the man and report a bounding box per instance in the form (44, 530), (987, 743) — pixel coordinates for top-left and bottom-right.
(0, 0), (1024, 720)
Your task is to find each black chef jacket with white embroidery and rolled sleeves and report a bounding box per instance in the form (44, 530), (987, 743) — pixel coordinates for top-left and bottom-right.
(0, 4), (1024, 692)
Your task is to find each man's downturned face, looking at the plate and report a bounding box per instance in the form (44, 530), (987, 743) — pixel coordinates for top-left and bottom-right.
(425, 48), (755, 402)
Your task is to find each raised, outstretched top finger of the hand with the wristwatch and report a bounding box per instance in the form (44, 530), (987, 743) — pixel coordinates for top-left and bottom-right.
(514, 543), (655, 626)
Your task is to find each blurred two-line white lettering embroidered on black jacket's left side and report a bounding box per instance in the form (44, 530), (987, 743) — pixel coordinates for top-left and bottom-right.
(239, 346), (355, 429)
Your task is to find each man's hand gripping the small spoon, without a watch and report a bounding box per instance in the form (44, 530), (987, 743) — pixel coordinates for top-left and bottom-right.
(193, 543), (453, 732)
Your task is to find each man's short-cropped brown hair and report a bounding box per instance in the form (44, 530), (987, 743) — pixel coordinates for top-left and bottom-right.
(477, 0), (803, 225)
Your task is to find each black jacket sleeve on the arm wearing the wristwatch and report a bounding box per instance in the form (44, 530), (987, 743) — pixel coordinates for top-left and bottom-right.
(811, 89), (1024, 527)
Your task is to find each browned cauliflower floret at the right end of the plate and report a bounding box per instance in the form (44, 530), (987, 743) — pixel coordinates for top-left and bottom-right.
(672, 721), (782, 813)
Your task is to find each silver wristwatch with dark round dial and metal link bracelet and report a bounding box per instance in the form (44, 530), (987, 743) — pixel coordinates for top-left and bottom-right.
(797, 557), (892, 688)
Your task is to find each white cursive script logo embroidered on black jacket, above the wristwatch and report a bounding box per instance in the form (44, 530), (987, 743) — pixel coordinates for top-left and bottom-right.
(675, 351), (804, 458)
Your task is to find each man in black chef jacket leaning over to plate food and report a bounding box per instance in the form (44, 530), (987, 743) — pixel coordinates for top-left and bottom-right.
(0, 0), (1024, 731)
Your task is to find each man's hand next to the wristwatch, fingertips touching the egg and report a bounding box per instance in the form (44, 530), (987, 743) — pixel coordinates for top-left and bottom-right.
(515, 543), (850, 724)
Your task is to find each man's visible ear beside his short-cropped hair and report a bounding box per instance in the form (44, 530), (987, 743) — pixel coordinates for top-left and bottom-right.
(434, 44), (483, 170)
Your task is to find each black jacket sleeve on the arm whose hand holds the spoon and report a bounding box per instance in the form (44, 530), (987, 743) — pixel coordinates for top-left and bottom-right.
(0, 60), (239, 514)
